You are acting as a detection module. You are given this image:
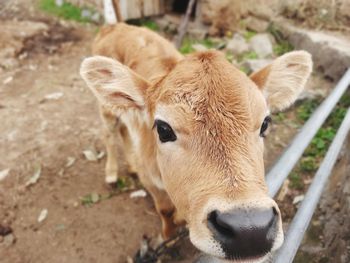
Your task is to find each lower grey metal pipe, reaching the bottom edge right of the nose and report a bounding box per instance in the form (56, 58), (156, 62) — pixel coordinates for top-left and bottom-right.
(273, 108), (350, 263)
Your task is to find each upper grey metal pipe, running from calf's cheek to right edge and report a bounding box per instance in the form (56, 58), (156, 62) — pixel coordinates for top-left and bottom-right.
(266, 68), (350, 197)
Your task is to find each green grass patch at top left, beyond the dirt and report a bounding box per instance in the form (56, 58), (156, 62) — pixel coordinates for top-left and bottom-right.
(39, 0), (95, 23)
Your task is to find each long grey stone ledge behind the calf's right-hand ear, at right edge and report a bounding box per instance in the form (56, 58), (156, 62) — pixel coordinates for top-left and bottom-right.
(276, 22), (350, 80)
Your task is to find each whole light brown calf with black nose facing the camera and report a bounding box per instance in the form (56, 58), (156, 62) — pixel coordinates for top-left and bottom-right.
(81, 24), (312, 262)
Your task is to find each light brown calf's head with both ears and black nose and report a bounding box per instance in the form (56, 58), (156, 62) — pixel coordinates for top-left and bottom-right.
(81, 51), (312, 262)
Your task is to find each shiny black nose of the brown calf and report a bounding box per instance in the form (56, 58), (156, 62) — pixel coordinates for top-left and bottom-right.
(208, 208), (278, 259)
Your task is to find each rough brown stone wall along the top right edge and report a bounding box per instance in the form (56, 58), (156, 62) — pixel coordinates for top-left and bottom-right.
(198, 0), (350, 34)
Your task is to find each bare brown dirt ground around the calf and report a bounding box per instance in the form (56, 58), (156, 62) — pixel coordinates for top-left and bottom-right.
(0, 1), (348, 263)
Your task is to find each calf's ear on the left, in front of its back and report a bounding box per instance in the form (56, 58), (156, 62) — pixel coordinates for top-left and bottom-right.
(80, 56), (149, 110)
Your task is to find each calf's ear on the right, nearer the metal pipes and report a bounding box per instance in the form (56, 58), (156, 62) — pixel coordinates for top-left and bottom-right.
(250, 51), (312, 111)
